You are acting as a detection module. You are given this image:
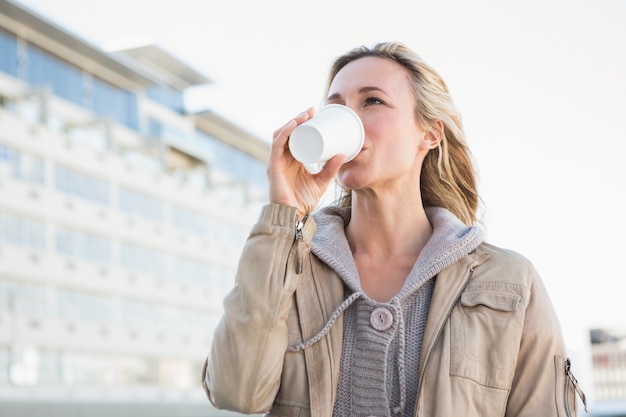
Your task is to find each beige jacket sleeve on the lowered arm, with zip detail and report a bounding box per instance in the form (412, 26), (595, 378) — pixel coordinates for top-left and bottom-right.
(506, 266), (584, 417)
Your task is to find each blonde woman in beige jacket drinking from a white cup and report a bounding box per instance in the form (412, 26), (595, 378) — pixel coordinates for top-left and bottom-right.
(203, 43), (578, 417)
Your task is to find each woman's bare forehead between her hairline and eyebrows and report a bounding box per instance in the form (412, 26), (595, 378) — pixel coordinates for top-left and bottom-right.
(329, 56), (410, 94)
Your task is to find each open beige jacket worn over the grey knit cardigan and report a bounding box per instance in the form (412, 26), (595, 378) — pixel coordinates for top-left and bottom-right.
(203, 205), (583, 417)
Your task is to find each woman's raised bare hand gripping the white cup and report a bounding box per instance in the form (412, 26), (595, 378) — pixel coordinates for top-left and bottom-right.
(267, 108), (346, 219)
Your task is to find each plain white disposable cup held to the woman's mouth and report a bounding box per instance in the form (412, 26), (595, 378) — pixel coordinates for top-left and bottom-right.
(289, 104), (365, 164)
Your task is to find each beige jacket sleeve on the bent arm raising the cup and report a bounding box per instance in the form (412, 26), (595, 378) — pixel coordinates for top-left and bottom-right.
(202, 205), (315, 414)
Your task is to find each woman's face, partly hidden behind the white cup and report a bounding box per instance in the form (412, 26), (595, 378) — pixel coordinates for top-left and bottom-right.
(327, 57), (437, 194)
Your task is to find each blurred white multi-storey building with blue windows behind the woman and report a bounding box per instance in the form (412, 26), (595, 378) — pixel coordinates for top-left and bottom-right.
(0, 0), (269, 417)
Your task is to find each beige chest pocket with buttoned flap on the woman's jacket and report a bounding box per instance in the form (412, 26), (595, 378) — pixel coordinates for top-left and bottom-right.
(450, 283), (523, 389)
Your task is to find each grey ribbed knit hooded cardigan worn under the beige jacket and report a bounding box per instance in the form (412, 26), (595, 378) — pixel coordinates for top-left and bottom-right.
(306, 207), (484, 417)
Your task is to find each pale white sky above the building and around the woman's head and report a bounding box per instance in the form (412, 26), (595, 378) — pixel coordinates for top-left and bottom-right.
(13, 0), (626, 374)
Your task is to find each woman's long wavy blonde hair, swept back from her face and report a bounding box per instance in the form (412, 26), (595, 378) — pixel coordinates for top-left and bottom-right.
(326, 42), (479, 225)
